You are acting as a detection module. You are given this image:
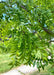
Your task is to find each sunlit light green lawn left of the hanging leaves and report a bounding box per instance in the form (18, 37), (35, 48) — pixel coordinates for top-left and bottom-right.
(0, 53), (11, 73)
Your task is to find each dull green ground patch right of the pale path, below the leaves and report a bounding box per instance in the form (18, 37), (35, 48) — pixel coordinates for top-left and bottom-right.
(29, 65), (54, 75)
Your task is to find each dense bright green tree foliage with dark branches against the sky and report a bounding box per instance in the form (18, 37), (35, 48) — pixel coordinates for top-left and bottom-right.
(0, 0), (54, 70)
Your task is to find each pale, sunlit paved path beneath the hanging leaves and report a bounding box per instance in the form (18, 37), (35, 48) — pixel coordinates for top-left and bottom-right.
(1, 65), (37, 75)
